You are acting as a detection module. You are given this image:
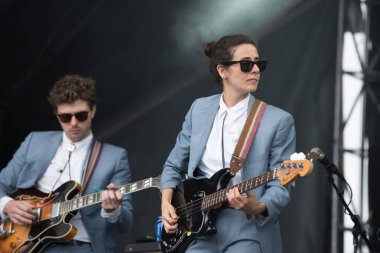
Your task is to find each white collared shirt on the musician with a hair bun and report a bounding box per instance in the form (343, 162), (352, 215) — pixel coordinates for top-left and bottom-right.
(198, 94), (249, 185)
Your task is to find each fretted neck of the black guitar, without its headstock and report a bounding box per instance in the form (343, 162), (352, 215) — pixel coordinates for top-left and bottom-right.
(201, 168), (278, 210)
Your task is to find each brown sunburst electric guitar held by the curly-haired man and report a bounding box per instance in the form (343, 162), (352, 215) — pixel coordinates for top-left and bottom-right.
(0, 176), (161, 253)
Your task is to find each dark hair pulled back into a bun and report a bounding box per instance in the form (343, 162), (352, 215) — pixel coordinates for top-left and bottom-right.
(203, 34), (256, 86)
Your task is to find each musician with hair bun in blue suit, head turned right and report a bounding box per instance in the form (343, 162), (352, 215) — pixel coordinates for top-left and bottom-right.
(161, 34), (296, 253)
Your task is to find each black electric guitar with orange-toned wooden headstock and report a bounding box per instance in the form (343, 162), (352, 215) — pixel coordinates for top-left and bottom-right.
(161, 159), (313, 253)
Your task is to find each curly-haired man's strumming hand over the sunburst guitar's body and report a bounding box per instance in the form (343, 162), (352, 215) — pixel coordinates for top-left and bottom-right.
(4, 200), (36, 226)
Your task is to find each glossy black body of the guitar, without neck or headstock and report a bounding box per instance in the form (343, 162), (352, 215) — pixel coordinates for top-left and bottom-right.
(161, 169), (233, 253)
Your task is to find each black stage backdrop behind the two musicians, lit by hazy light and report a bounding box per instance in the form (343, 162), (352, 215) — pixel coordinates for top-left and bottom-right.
(0, 0), (338, 253)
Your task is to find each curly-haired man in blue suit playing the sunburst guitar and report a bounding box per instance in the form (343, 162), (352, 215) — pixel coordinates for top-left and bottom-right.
(0, 75), (133, 253)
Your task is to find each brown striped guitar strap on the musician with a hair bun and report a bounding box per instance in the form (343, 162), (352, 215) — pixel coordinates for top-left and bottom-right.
(230, 99), (267, 175)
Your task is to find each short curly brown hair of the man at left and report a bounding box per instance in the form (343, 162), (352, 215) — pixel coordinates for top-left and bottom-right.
(47, 75), (96, 112)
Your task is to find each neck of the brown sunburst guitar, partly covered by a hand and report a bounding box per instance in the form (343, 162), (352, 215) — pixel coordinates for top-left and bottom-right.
(57, 177), (160, 214)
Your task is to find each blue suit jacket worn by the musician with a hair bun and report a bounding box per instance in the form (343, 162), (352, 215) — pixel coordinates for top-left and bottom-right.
(161, 94), (296, 253)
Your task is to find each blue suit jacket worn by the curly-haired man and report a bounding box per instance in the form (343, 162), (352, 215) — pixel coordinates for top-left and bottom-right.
(0, 131), (133, 253)
